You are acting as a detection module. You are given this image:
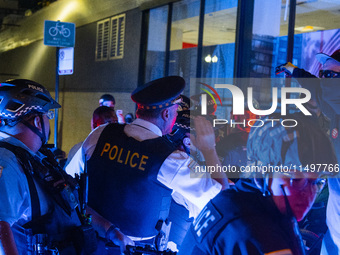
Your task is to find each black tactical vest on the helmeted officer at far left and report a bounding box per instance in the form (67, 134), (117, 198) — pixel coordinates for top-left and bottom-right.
(0, 142), (85, 255)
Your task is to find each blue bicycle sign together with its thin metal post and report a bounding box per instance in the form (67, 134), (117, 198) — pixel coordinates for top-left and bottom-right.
(44, 20), (76, 148)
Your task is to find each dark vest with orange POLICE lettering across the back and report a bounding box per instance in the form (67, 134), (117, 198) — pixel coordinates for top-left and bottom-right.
(87, 124), (175, 237)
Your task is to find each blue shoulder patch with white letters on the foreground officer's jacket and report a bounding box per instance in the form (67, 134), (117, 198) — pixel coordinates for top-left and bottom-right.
(191, 203), (222, 243)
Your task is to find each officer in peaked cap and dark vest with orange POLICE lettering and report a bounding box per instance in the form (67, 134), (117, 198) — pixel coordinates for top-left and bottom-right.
(66, 76), (227, 247)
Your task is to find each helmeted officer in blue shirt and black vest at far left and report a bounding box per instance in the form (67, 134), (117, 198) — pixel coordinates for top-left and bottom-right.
(0, 79), (129, 255)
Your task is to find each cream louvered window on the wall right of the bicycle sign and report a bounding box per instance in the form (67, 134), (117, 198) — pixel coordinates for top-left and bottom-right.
(96, 14), (125, 61)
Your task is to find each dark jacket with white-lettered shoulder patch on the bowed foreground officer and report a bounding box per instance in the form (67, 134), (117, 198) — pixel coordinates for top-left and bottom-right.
(179, 179), (301, 255)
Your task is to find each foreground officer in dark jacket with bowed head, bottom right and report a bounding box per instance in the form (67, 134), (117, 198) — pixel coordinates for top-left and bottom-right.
(179, 114), (336, 255)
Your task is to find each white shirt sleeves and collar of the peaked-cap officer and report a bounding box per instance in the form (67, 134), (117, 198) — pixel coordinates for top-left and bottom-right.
(66, 119), (222, 216)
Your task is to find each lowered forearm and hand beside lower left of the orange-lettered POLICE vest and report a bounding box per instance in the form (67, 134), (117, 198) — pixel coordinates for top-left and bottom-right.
(86, 207), (134, 253)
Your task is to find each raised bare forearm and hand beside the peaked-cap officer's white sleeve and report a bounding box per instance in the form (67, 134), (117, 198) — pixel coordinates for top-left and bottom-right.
(190, 116), (229, 190)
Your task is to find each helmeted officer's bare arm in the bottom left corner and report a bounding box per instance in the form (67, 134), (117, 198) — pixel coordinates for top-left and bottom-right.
(0, 221), (19, 255)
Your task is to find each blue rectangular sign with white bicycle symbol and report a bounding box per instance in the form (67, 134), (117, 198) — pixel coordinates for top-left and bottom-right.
(44, 20), (75, 47)
